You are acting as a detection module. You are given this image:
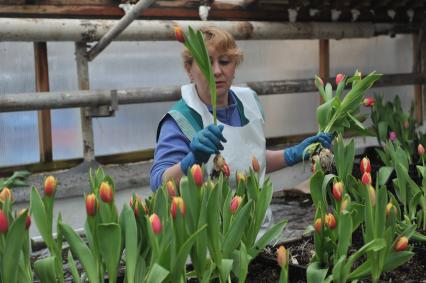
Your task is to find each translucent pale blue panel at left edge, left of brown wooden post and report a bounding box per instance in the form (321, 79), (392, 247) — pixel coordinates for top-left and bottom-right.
(0, 42), (39, 166)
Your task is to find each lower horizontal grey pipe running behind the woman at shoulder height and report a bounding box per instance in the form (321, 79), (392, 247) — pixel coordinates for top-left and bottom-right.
(0, 73), (426, 112)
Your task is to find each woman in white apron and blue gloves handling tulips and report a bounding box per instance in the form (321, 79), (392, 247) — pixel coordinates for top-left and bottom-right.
(151, 27), (331, 191)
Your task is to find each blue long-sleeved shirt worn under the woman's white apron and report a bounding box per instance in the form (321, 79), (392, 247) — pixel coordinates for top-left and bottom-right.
(150, 91), (242, 191)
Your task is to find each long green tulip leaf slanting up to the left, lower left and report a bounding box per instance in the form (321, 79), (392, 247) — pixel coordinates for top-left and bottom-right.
(58, 223), (99, 283)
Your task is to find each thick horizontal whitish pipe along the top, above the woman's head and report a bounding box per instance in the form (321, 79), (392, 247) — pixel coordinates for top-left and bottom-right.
(0, 18), (418, 42)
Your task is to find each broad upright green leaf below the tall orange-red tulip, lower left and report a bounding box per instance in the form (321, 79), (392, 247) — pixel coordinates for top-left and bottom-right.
(97, 223), (121, 282)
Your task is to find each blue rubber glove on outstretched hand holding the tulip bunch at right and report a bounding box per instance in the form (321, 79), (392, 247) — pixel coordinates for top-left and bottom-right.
(284, 133), (333, 166)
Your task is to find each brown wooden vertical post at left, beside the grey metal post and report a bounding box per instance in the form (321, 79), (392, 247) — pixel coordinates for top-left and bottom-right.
(34, 42), (52, 163)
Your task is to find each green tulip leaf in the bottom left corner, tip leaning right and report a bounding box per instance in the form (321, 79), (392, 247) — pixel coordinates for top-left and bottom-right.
(2, 213), (27, 283)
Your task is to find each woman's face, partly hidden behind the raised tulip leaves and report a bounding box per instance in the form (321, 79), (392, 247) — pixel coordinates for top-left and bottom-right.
(185, 47), (237, 107)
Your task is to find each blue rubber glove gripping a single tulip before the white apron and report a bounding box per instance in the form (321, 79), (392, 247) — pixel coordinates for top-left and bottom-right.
(180, 124), (226, 174)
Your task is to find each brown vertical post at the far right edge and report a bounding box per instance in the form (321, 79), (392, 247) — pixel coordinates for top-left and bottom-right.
(412, 33), (424, 125)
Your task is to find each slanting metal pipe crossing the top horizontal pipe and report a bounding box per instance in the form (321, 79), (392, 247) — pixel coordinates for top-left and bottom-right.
(87, 0), (154, 61)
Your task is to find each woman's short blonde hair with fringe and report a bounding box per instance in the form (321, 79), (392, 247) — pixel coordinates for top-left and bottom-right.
(182, 26), (244, 65)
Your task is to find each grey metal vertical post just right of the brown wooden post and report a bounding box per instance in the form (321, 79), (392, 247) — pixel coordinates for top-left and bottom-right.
(75, 42), (95, 163)
